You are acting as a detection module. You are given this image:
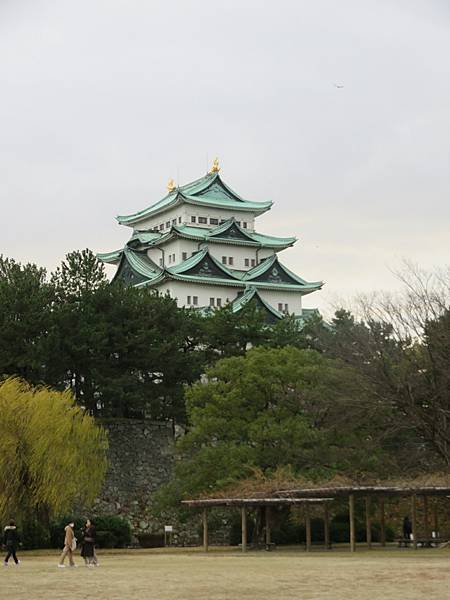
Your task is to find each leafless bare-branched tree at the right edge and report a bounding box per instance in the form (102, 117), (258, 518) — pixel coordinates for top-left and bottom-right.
(358, 261), (450, 465)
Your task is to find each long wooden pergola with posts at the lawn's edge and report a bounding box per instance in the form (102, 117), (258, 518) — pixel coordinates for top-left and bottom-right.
(183, 485), (450, 552)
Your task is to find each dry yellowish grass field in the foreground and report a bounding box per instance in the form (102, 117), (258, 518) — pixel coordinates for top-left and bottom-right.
(0, 549), (450, 600)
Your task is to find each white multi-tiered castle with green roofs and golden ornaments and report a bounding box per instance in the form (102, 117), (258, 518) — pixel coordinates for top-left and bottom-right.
(97, 159), (322, 322)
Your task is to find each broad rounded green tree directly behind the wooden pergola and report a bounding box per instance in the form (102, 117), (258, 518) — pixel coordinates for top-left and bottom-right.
(156, 347), (395, 499)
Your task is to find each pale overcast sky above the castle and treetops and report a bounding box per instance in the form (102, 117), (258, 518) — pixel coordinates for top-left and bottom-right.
(0, 0), (450, 310)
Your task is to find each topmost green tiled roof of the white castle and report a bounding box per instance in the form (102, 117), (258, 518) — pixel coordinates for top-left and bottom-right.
(117, 173), (272, 225)
